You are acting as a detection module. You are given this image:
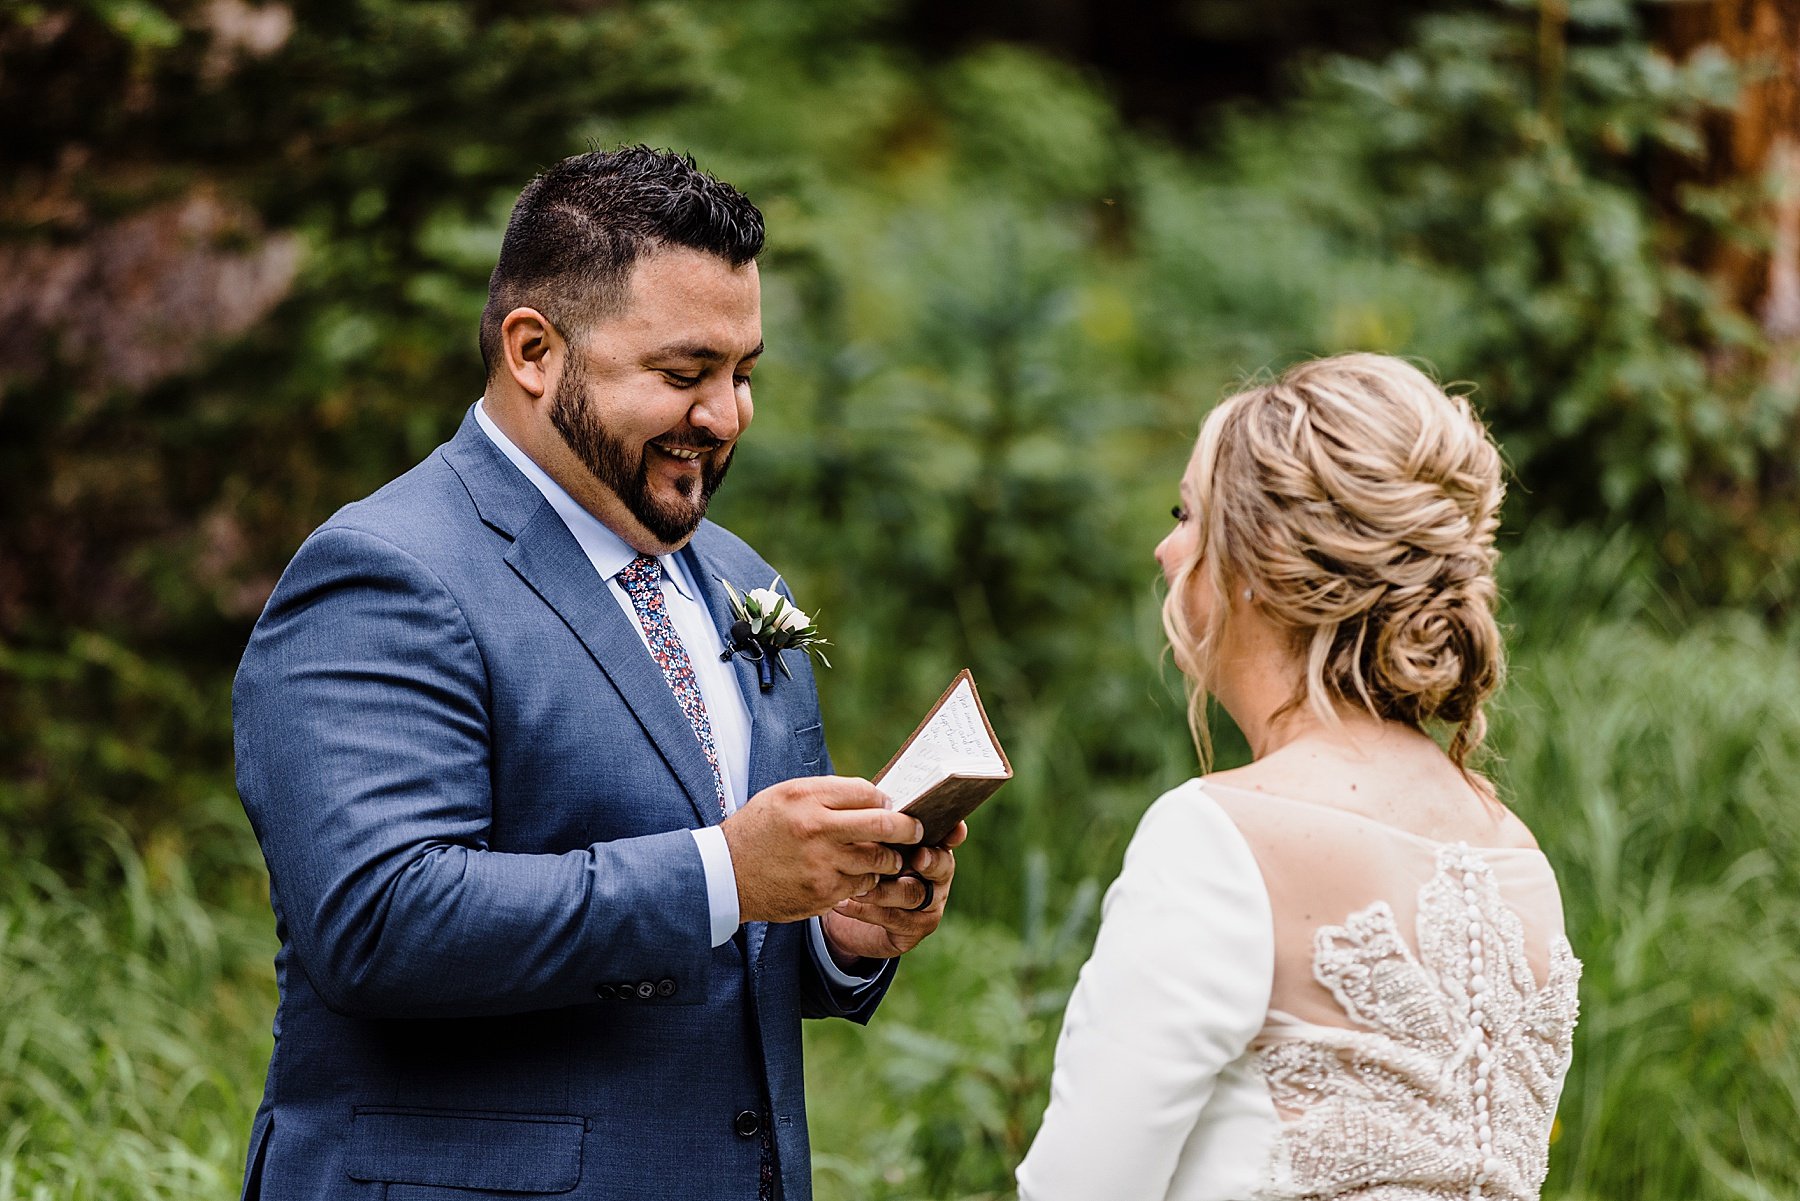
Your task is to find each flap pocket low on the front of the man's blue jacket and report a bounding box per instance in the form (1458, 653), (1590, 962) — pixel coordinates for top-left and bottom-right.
(347, 1106), (587, 1194)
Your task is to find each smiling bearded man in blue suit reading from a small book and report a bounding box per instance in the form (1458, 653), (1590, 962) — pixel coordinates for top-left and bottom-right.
(234, 148), (963, 1201)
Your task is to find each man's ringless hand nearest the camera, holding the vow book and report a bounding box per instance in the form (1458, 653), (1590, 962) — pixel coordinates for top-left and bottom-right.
(720, 776), (923, 922)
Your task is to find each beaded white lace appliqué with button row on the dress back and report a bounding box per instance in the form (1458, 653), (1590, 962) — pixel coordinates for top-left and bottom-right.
(1258, 844), (1580, 1201)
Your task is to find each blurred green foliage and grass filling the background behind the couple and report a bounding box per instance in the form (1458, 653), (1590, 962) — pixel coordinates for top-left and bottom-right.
(0, 0), (1800, 1201)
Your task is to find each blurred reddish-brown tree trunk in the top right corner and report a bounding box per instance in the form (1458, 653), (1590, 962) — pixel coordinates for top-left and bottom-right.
(1658, 0), (1800, 348)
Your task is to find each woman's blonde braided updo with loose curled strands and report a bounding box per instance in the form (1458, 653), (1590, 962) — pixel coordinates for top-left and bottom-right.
(1163, 355), (1505, 774)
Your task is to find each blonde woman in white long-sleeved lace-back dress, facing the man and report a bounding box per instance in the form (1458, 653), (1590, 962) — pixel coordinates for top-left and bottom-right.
(1019, 355), (1580, 1201)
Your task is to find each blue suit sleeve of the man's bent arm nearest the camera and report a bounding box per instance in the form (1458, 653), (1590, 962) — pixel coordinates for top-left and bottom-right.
(232, 528), (711, 1017)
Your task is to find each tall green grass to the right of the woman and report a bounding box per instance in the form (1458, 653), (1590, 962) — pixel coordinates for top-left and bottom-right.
(1496, 540), (1800, 1201)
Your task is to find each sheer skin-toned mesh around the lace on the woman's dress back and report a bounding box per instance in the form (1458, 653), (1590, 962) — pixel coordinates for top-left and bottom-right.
(1204, 780), (1562, 1026)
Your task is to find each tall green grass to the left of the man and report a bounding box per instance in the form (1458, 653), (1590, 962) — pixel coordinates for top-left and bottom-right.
(0, 799), (275, 1201)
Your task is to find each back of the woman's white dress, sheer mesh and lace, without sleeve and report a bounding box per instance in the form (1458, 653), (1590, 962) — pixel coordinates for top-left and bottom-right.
(1208, 787), (1580, 1201)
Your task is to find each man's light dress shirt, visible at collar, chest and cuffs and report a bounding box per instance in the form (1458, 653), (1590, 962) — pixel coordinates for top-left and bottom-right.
(475, 400), (875, 989)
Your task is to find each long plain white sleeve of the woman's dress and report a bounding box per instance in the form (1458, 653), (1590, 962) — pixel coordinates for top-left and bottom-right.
(1019, 781), (1274, 1201)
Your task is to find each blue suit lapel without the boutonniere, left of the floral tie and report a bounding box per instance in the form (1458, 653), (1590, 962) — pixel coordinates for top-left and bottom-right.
(445, 414), (720, 825)
